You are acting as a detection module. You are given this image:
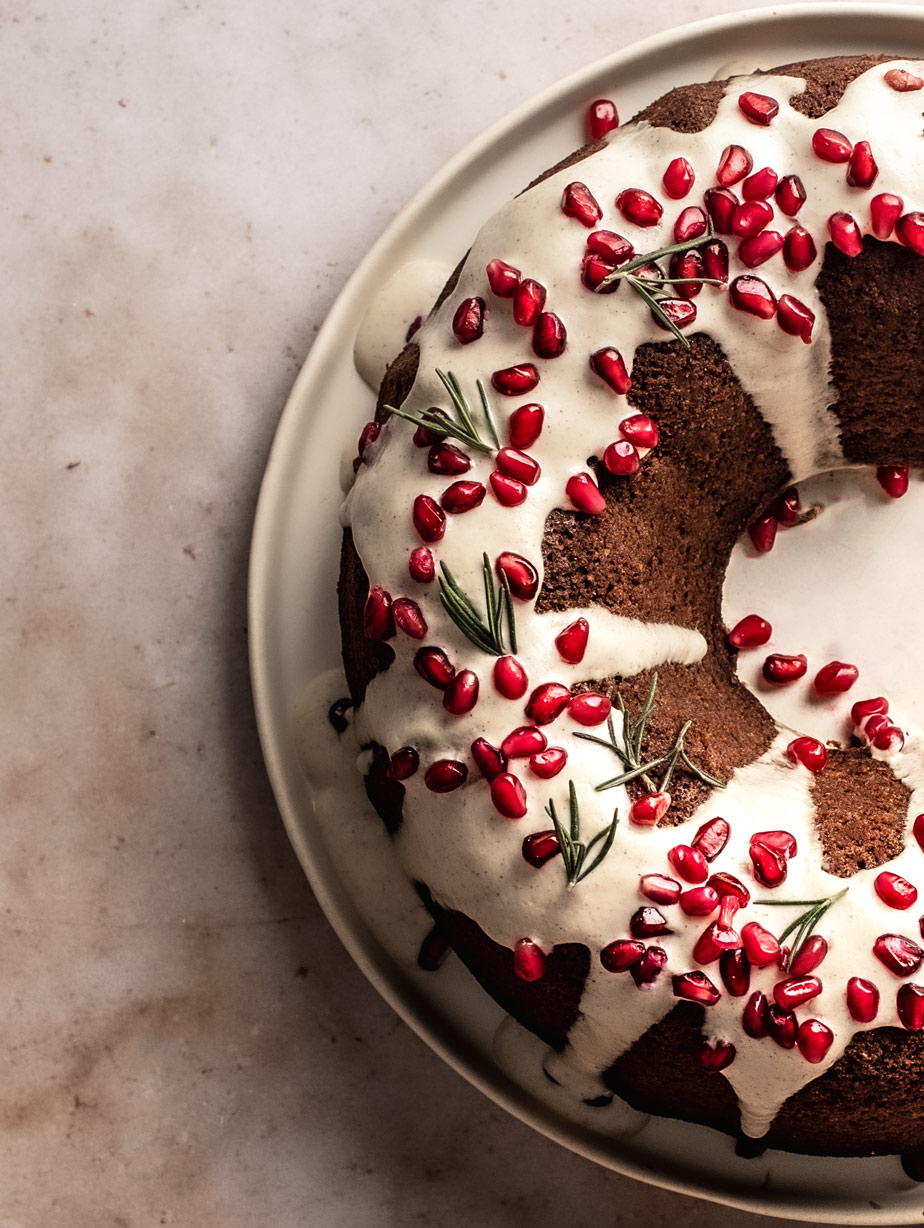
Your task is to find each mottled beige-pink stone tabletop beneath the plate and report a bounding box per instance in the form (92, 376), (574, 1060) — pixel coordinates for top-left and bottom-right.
(0, 0), (919, 1228)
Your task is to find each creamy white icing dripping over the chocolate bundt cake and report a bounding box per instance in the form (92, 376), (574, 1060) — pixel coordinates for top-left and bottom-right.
(334, 61), (924, 1135)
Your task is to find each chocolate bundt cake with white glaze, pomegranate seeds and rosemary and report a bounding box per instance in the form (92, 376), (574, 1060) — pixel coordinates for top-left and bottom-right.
(340, 56), (924, 1154)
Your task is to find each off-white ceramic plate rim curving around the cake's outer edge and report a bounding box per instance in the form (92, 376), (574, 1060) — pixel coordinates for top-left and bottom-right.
(249, 4), (924, 1224)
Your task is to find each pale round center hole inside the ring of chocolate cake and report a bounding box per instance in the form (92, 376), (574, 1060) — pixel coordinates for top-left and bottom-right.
(722, 468), (924, 744)
